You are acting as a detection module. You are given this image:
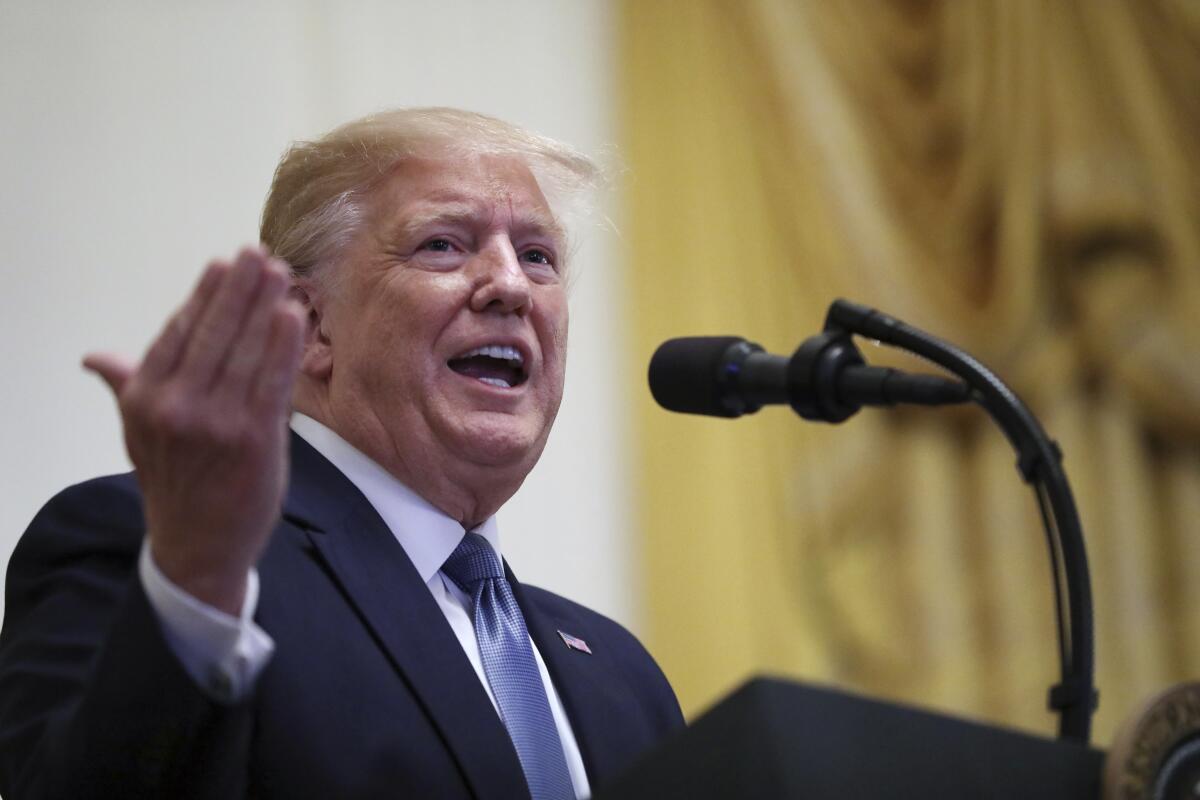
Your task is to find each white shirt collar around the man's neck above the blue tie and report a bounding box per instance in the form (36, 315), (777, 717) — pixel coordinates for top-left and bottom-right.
(292, 411), (503, 583)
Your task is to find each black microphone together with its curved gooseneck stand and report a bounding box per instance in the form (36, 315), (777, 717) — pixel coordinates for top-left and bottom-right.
(649, 300), (1099, 743)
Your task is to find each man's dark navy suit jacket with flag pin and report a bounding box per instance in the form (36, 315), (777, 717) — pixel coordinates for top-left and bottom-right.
(0, 437), (683, 800)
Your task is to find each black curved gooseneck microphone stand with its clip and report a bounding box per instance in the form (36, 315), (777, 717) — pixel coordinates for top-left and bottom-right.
(811, 300), (1098, 745)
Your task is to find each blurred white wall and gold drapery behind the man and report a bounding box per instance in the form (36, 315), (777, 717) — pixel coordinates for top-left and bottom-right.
(0, 0), (1200, 744)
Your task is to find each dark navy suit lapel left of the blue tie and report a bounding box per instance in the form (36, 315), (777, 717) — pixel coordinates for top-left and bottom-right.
(284, 434), (529, 800)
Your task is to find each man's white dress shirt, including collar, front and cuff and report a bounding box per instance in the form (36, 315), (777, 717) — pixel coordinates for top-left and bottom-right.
(138, 414), (590, 800)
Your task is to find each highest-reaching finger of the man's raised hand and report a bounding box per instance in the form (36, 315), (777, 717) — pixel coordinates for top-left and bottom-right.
(178, 247), (266, 391)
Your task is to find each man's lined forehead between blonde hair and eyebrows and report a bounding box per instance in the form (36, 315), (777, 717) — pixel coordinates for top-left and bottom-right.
(371, 155), (563, 239)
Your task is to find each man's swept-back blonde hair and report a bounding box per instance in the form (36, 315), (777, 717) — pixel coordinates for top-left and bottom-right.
(259, 108), (602, 284)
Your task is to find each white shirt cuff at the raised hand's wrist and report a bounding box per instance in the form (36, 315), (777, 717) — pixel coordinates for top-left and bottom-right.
(138, 539), (275, 703)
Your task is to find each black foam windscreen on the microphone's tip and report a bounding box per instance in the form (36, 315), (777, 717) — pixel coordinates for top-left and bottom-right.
(650, 336), (745, 416)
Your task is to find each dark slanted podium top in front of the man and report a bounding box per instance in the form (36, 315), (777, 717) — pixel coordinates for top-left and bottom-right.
(594, 678), (1104, 800)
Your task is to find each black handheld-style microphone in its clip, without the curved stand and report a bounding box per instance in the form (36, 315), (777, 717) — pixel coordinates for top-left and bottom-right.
(649, 331), (972, 422)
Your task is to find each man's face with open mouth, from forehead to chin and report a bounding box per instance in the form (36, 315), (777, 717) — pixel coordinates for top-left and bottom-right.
(323, 156), (568, 480)
